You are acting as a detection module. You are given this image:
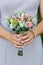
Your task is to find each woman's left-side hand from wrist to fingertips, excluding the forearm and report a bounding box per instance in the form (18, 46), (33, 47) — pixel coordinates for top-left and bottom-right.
(8, 34), (23, 48)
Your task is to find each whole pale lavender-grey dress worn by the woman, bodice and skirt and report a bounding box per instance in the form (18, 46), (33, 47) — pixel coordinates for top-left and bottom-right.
(0, 0), (42, 65)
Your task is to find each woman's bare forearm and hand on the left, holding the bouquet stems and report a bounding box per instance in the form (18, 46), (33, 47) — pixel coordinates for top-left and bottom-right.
(0, 26), (23, 48)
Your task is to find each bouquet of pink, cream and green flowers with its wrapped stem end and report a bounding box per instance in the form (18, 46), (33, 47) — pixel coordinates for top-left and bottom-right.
(7, 11), (34, 56)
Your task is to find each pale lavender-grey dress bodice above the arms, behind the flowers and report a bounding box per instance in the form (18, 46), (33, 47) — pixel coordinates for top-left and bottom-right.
(0, 0), (39, 28)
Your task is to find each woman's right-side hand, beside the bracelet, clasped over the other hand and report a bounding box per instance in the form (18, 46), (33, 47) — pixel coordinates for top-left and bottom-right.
(19, 31), (34, 45)
